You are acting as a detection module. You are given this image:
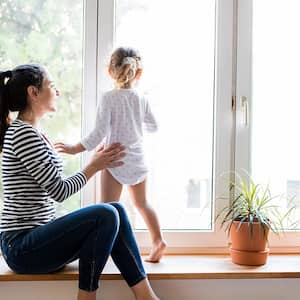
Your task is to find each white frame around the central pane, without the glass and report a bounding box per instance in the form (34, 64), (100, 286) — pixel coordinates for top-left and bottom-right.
(82, 0), (234, 253)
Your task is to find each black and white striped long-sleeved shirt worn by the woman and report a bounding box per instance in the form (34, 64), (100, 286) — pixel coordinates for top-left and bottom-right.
(0, 120), (87, 231)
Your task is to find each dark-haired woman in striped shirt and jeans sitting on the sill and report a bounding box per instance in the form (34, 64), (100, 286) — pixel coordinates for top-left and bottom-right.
(0, 64), (158, 300)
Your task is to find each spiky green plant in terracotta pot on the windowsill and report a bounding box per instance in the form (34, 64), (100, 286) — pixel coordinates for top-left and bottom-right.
(217, 174), (292, 266)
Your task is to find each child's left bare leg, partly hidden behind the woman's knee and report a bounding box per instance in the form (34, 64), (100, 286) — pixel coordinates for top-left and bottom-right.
(101, 170), (122, 202)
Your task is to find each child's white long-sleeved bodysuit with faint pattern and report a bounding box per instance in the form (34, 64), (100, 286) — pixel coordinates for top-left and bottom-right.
(81, 89), (157, 185)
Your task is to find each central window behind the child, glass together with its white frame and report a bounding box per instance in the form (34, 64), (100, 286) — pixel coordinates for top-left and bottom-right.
(96, 0), (233, 252)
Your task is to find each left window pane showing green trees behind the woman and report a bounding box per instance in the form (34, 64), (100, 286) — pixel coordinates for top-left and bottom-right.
(0, 0), (83, 214)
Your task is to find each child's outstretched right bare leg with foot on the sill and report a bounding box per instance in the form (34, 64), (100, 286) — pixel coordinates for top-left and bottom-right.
(128, 180), (166, 262)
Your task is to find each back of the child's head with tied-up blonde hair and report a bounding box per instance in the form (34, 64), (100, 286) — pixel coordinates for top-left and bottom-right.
(109, 47), (142, 88)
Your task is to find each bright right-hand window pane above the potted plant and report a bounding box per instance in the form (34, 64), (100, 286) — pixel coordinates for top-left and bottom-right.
(251, 0), (300, 227)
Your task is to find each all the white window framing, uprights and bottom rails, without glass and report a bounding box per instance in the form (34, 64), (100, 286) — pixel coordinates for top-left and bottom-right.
(82, 0), (300, 253)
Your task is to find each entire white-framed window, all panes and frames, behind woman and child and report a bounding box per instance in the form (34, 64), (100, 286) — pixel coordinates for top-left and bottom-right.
(4, 0), (300, 253)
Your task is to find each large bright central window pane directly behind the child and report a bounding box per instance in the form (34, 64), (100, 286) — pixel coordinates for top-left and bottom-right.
(115, 0), (215, 230)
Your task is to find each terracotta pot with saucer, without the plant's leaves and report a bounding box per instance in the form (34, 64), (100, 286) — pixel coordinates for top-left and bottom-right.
(230, 221), (270, 266)
